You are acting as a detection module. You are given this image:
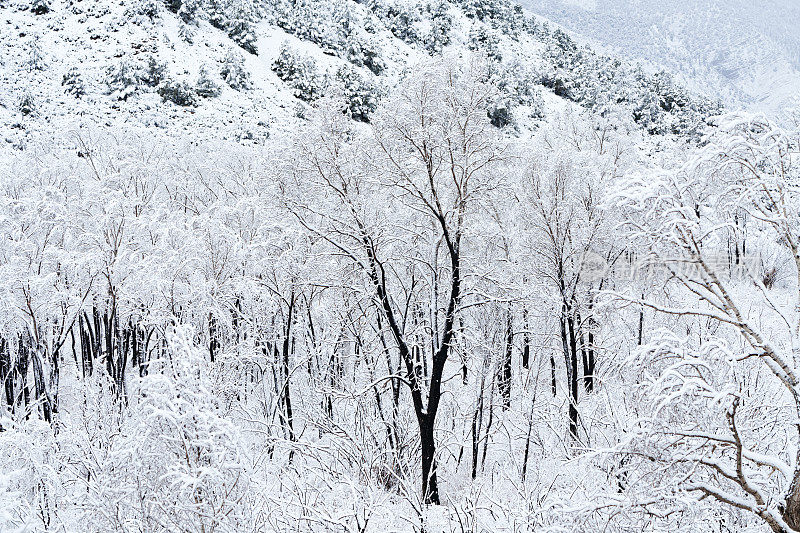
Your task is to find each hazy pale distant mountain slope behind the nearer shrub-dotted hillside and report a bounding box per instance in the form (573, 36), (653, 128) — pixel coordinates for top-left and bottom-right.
(522, 0), (800, 116)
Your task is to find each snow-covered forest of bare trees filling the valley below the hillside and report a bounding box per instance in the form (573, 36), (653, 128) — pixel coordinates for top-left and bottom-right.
(0, 2), (800, 533)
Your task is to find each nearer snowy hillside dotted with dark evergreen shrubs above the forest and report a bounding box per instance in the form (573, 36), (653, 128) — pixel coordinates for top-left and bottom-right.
(0, 0), (720, 149)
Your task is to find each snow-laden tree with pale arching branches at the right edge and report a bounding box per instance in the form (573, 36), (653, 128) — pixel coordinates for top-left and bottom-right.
(617, 116), (800, 532)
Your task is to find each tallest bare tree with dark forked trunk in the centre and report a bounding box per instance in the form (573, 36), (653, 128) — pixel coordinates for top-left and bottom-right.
(287, 60), (500, 504)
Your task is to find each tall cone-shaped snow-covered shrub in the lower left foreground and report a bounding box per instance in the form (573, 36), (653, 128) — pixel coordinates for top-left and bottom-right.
(81, 329), (260, 531)
